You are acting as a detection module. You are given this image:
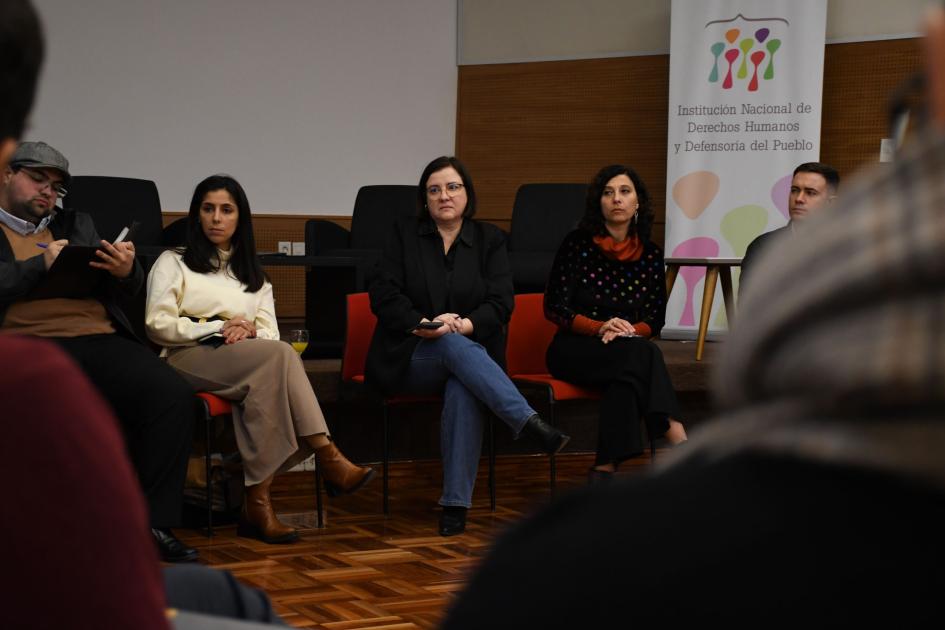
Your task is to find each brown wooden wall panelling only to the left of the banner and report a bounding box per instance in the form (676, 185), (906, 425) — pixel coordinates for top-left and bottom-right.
(456, 55), (669, 247)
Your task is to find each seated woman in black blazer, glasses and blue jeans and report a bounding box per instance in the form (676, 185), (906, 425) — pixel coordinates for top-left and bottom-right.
(366, 156), (569, 536)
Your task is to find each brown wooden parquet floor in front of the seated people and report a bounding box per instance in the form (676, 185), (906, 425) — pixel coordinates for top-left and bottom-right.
(176, 453), (660, 630)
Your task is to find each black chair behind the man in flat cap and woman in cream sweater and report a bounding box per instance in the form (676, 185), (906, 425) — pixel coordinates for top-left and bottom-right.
(63, 175), (164, 339)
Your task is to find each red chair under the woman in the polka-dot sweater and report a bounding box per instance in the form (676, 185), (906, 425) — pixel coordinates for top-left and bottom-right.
(506, 293), (654, 494)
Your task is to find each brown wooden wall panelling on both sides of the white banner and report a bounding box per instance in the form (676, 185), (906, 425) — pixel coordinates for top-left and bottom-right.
(456, 39), (919, 251)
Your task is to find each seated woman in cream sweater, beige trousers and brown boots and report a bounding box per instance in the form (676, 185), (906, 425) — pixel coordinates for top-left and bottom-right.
(145, 175), (374, 543)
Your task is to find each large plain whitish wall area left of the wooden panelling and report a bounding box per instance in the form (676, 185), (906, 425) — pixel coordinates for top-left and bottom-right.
(26, 0), (456, 215)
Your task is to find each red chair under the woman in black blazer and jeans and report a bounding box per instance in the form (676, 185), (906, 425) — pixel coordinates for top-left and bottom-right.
(341, 293), (495, 515)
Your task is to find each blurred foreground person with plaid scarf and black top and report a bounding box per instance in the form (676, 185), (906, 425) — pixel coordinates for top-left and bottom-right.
(444, 9), (945, 630)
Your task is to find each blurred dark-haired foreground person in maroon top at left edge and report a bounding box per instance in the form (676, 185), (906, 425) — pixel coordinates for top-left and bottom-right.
(0, 0), (288, 630)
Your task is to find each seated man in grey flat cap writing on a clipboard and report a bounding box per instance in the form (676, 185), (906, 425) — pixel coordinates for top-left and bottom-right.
(0, 142), (197, 562)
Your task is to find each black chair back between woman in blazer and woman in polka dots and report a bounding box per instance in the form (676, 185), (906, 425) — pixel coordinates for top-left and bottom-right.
(509, 184), (587, 293)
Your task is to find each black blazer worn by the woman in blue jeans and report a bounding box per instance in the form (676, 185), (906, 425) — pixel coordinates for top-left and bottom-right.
(366, 217), (515, 394)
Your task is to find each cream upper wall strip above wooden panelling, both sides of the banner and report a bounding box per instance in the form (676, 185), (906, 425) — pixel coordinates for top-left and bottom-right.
(458, 0), (932, 65)
